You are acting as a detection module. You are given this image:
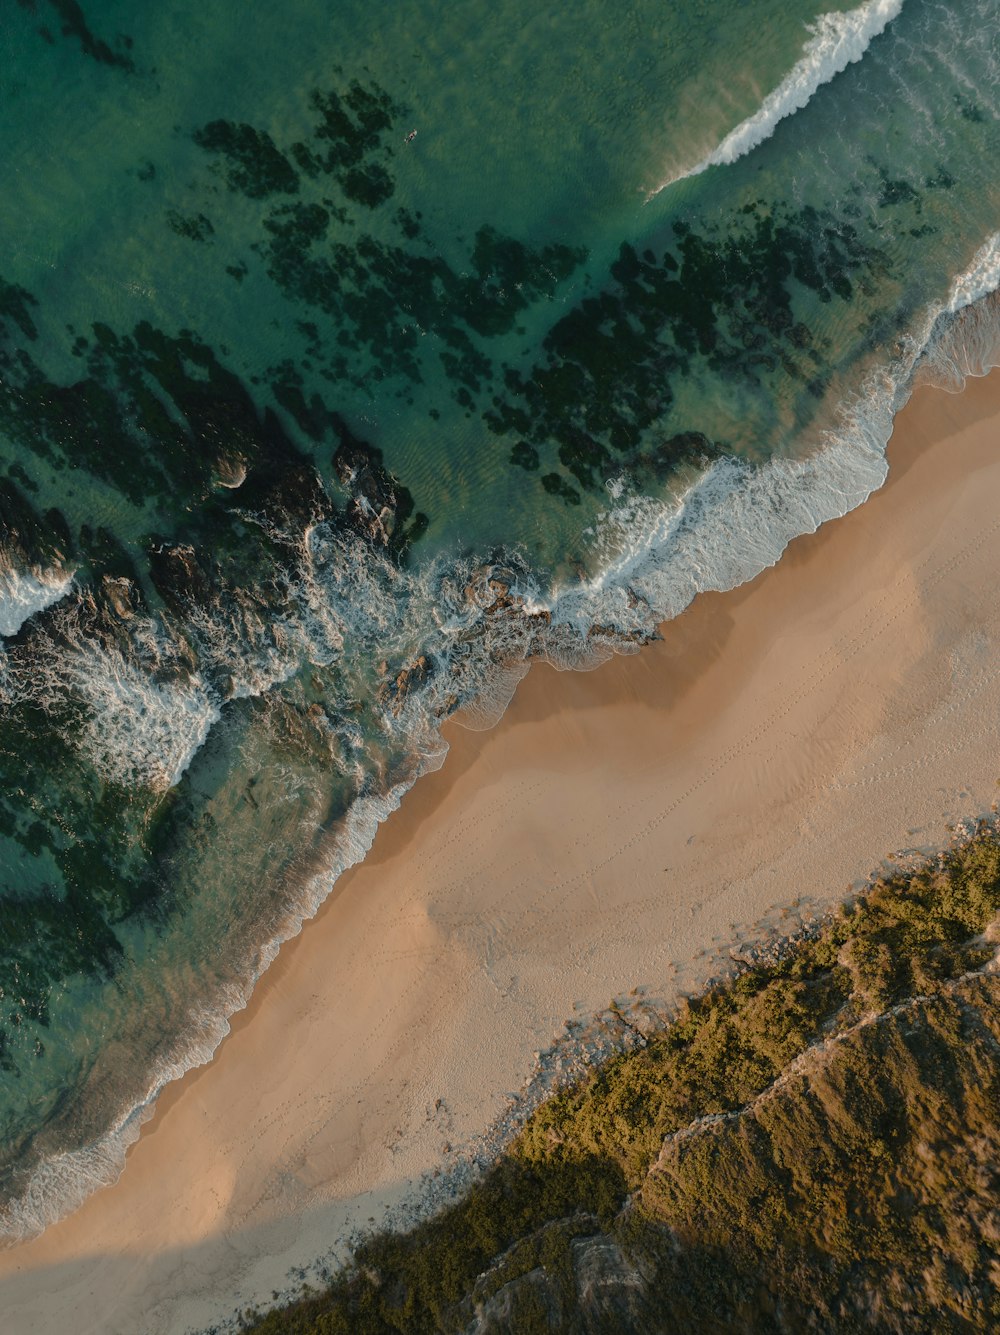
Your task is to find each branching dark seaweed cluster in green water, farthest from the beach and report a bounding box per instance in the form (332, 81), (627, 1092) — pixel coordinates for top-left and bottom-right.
(186, 80), (585, 397)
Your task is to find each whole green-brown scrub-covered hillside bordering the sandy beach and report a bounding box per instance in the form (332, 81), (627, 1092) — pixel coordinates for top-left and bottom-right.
(244, 822), (1000, 1335)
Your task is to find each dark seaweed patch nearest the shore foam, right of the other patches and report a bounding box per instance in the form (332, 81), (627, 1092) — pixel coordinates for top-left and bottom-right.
(486, 204), (888, 499)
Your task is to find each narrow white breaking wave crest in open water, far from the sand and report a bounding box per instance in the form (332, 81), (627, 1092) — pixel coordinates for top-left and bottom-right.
(649, 0), (903, 199)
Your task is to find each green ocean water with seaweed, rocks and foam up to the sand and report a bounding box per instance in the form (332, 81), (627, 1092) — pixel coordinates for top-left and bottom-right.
(0, 0), (1000, 1239)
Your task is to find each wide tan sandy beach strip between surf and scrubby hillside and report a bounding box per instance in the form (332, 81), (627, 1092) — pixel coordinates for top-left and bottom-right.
(0, 375), (1000, 1335)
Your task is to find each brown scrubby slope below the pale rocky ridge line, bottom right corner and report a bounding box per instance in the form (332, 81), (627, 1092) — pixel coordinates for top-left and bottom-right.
(445, 968), (1000, 1335)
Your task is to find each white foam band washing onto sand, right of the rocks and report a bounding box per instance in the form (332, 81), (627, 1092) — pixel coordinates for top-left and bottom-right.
(551, 234), (1000, 651)
